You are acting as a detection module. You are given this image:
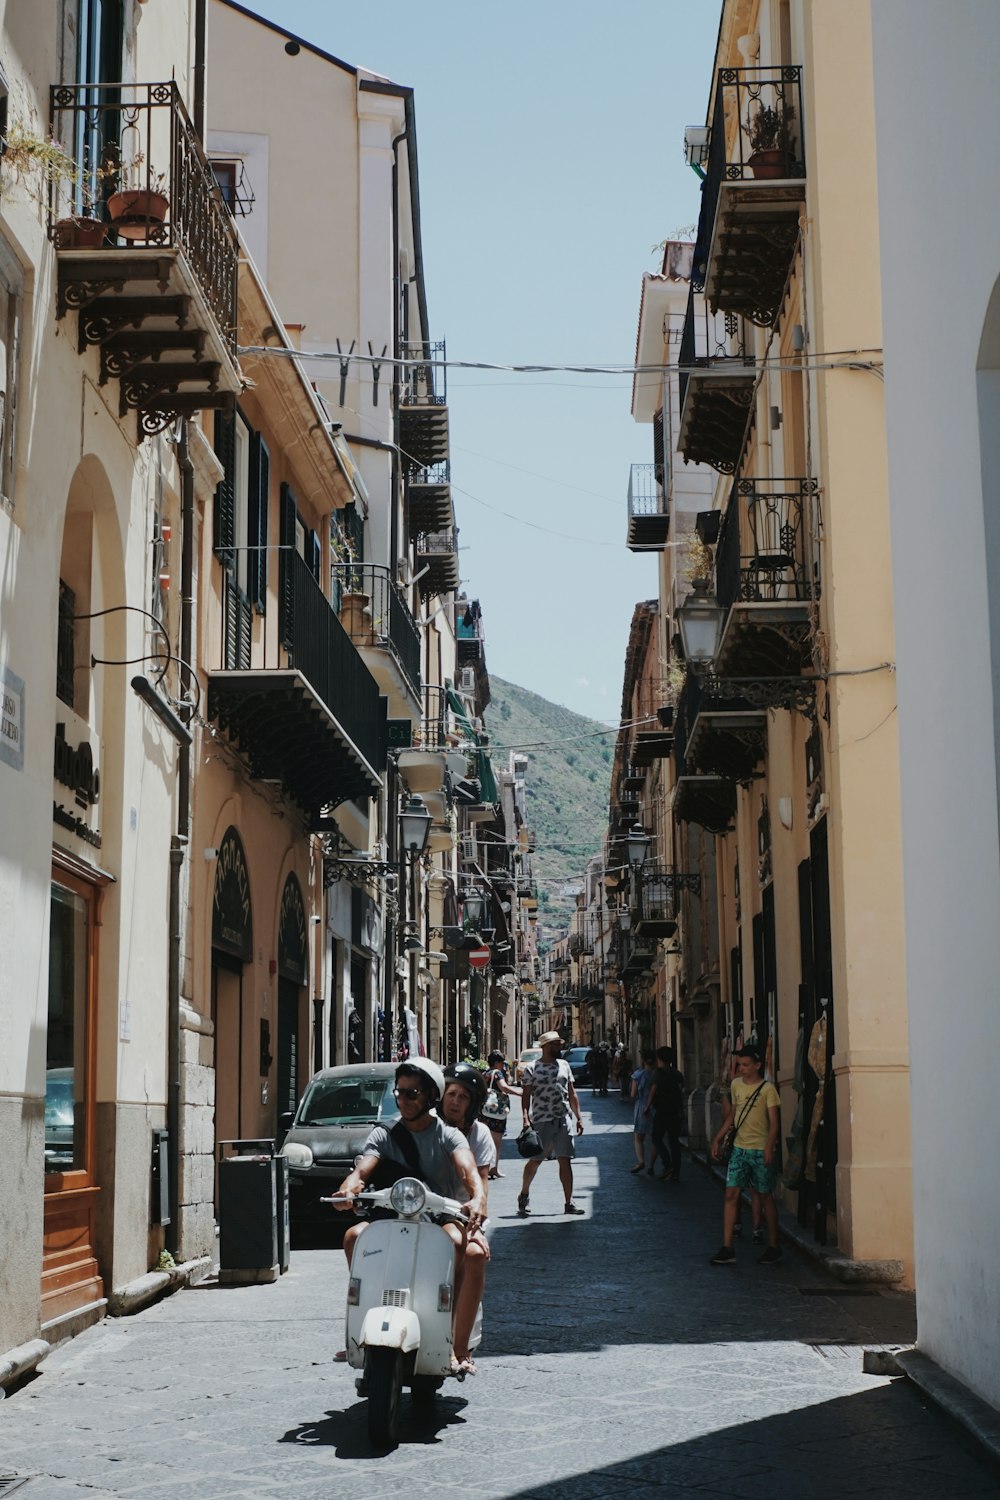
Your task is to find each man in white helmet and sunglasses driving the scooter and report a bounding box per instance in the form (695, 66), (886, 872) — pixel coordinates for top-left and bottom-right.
(337, 1058), (486, 1374)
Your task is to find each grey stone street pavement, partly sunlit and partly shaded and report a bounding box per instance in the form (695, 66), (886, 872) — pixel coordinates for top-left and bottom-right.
(0, 1091), (1000, 1500)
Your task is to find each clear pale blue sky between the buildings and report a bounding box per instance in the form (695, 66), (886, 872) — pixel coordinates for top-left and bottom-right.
(244, 0), (720, 722)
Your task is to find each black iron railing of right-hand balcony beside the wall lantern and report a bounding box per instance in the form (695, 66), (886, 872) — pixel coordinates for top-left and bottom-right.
(715, 479), (820, 608)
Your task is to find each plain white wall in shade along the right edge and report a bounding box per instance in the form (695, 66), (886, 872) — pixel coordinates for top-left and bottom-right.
(871, 0), (1000, 1406)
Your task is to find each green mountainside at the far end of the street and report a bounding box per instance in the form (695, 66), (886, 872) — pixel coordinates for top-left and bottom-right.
(484, 672), (616, 947)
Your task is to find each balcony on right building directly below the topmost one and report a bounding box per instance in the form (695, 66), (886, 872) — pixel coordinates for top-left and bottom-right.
(678, 288), (756, 474)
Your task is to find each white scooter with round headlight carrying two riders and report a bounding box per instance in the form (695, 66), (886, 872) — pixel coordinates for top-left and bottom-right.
(322, 1178), (483, 1448)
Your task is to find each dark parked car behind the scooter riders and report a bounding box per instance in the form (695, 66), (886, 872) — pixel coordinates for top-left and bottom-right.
(280, 1062), (399, 1224)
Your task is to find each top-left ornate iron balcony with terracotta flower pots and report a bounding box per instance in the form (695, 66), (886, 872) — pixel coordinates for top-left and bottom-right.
(48, 83), (241, 438)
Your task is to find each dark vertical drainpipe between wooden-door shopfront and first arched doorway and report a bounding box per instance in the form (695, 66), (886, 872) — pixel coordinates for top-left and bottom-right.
(166, 422), (195, 1256)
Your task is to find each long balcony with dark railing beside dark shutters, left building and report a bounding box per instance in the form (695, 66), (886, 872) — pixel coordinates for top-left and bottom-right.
(208, 548), (385, 830)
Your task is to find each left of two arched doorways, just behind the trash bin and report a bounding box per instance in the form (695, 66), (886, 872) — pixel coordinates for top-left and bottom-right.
(211, 827), (253, 1142)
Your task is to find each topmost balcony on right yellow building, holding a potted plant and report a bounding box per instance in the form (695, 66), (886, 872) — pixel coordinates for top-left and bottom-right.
(691, 66), (805, 327)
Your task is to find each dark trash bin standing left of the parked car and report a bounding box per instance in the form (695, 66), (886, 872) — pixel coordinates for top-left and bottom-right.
(219, 1140), (288, 1284)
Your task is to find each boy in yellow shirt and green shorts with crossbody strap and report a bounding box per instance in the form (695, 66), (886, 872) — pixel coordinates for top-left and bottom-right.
(711, 1047), (781, 1266)
